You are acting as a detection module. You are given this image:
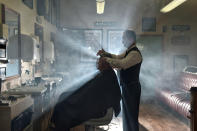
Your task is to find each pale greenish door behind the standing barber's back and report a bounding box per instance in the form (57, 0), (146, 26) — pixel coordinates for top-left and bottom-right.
(137, 35), (163, 100)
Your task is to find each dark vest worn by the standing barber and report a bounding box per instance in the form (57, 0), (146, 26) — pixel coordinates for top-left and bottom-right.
(120, 47), (142, 84)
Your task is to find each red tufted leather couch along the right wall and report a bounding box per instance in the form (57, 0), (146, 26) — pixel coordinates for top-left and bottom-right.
(156, 66), (197, 131)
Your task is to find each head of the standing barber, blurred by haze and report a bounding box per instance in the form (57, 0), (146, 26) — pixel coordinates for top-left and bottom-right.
(122, 29), (136, 48)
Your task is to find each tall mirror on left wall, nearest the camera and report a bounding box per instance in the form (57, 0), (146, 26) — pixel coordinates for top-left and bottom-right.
(5, 8), (20, 77)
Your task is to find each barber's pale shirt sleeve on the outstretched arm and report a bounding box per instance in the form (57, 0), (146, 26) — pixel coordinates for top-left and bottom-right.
(105, 51), (142, 69)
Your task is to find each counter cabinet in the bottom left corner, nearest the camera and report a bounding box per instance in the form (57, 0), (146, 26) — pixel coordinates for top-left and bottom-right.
(0, 96), (33, 131)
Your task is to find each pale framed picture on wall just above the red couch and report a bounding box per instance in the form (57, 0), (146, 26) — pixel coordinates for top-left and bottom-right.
(174, 55), (189, 73)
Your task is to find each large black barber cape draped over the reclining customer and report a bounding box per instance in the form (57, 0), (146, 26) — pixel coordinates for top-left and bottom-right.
(52, 69), (121, 131)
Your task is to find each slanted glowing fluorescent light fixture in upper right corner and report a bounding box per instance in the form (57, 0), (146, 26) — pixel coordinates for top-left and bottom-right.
(160, 0), (187, 13)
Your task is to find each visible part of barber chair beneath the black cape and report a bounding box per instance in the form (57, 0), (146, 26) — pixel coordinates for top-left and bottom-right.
(84, 108), (113, 131)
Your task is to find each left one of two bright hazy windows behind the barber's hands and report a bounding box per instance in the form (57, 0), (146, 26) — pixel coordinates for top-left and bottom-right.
(60, 28), (103, 62)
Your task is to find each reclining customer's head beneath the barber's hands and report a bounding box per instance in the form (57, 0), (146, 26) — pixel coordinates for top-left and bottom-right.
(97, 57), (112, 72)
